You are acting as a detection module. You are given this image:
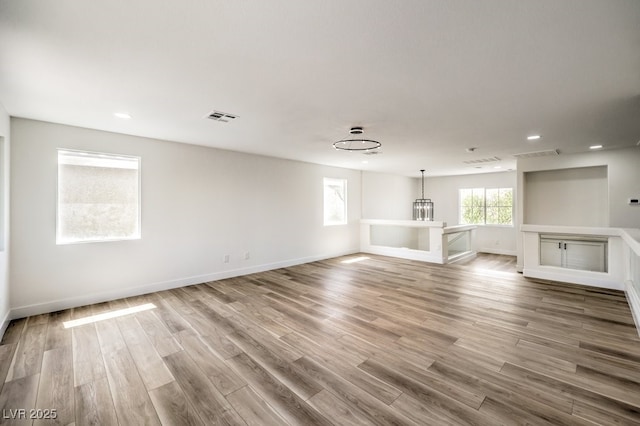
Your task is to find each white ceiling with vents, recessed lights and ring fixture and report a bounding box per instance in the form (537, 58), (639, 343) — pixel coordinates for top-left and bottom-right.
(0, 0), (640, 176)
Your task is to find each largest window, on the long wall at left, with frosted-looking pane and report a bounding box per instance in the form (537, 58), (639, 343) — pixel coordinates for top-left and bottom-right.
(56, 150), (140, 244)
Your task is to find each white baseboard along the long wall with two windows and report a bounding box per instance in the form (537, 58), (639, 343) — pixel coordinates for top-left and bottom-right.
(10, 249), (360, 320)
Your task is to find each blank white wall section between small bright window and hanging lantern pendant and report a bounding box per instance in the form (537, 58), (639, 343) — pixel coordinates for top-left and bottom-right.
(362, 172), (420, 220)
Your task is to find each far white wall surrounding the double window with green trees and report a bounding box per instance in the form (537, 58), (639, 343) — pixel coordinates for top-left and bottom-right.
(418, 172), (518, 255)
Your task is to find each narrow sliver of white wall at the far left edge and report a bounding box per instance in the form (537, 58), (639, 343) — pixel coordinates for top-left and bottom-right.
(0, 103), (10, 336)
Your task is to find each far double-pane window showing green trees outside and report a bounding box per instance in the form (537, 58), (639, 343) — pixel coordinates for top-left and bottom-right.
(460, 188), (513, 225)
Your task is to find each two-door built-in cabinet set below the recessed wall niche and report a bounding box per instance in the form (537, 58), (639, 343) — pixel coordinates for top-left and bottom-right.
(540, 234), (608, 272)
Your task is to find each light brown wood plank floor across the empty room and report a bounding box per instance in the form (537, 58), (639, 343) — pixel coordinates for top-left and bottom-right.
(0, 255), (640, 425)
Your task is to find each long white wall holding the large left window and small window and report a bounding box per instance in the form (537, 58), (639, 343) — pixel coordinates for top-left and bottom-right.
(10, 118), (361, 316)
